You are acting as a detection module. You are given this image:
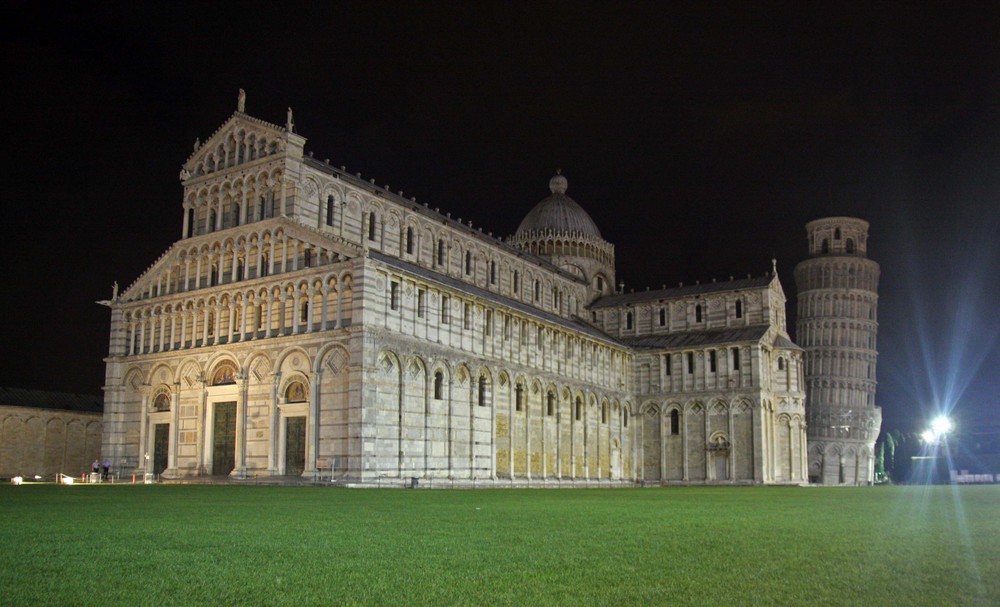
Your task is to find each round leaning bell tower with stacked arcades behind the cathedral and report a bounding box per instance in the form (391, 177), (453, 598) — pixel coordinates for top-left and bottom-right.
(795, 217), (882, 485)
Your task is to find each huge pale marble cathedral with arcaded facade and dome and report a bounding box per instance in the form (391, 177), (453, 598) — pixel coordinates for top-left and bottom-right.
(102, 92), (877, 486)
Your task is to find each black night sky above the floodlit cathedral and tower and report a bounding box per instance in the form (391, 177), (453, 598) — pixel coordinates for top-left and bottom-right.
(0, 2), (1000, 428)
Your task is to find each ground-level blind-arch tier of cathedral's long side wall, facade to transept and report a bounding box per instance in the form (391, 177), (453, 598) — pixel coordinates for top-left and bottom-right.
(363, 338), (633, 480)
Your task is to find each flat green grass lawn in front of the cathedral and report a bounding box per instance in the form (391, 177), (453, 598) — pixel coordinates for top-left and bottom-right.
(0, 485), (1000, 606)
